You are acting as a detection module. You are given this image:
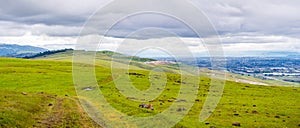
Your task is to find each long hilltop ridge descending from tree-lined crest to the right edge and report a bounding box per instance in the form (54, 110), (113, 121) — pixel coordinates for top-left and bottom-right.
(29, 49), (300, 87)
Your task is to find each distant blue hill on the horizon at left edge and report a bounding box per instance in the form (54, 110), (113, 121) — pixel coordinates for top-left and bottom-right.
(0, 44), (47, 58)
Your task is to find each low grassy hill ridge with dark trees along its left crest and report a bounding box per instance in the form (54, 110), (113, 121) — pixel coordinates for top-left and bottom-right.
(28, 49), (182, 73)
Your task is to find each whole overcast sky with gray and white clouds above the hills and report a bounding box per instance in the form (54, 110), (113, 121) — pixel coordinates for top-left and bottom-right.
(0, 0), (300, 56)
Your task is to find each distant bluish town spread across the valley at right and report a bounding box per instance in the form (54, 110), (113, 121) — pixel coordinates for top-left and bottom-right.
(157, 56), (300, 83)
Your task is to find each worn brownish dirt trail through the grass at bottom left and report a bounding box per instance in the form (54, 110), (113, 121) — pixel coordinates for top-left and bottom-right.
(34, 96), (101, 128)
